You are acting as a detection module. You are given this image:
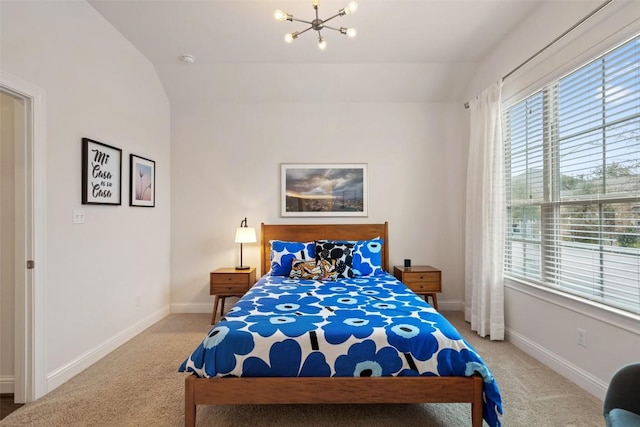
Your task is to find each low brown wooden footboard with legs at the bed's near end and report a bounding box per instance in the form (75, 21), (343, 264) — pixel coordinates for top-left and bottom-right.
(184, 375), (483, 427)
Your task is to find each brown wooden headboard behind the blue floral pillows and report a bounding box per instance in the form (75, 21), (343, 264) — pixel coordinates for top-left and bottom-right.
(260, 222), (389, 274)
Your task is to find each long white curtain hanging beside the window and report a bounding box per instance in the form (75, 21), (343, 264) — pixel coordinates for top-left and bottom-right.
(464, 82), (505, 340)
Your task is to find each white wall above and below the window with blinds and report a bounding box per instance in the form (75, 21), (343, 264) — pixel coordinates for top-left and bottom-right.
(467, 1), (640, 398)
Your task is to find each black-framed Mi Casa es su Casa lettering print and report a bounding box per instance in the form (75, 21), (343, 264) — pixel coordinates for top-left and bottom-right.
(82, 138), (122, 205)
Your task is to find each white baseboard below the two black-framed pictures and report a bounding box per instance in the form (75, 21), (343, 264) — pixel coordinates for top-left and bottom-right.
(47, 306), (170, 393)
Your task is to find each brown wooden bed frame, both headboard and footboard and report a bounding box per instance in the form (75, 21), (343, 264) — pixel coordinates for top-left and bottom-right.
(184, 222), (483, 427)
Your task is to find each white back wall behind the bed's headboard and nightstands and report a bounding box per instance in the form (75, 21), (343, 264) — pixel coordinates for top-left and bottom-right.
(171, 100), (466, 311)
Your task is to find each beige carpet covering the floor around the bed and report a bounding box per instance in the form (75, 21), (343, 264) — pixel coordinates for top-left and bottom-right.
(0, 312), (604, 427)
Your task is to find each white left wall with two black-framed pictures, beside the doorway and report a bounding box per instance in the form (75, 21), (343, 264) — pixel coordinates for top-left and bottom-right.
(0, 1), (171, 396)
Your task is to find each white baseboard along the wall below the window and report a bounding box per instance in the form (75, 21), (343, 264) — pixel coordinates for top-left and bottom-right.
(505, 328), (608, 400)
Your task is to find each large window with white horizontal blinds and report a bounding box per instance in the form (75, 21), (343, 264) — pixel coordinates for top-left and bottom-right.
(504, 36), (640, 314)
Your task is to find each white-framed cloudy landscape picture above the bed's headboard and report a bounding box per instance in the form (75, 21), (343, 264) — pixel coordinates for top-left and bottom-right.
(280, 163), (367, 217)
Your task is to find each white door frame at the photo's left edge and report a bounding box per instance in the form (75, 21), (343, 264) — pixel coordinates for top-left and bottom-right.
(0, 70), (47, 403)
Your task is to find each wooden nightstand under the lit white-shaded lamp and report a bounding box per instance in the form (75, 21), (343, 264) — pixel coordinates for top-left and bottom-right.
(209, 267), (256, 325)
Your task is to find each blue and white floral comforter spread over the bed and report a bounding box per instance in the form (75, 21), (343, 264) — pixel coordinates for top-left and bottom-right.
(179, 273), (502, 427)
